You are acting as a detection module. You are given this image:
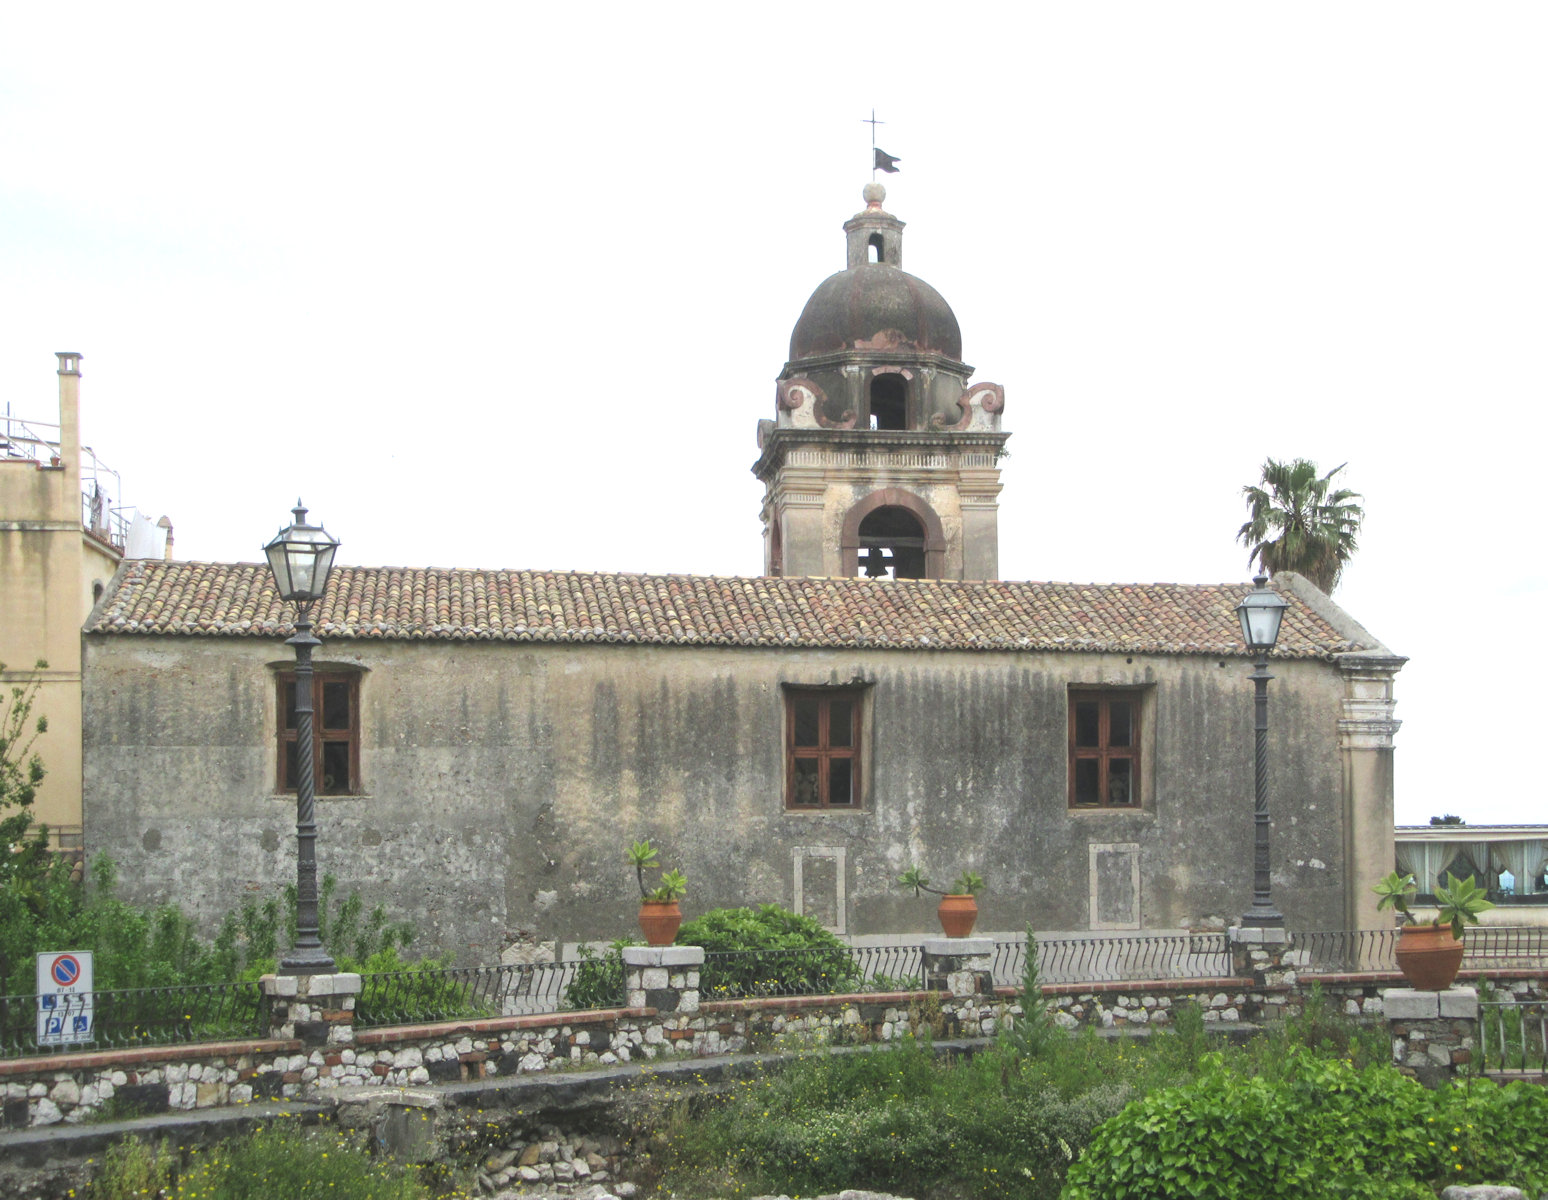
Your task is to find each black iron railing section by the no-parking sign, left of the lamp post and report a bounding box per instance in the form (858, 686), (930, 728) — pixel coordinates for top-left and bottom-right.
(0, 983), (265, 1058)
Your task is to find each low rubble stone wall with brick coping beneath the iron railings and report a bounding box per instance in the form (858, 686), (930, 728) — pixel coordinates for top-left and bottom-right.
(0, 965), (1548, 1127)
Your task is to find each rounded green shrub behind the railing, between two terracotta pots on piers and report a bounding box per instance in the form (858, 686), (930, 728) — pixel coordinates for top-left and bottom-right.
(676, 904), (861, 999)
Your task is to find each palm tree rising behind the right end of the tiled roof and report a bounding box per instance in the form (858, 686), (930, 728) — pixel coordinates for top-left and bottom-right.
(1237, 458), (1365, 591)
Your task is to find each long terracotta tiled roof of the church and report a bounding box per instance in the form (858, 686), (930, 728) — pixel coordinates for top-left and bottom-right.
(88, 559), (1368, 658)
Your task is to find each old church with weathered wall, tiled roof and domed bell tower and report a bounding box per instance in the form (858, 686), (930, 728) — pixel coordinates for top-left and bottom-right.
(82, 183), (1404, 962)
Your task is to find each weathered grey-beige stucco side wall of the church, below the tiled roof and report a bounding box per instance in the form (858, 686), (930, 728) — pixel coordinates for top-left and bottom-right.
(84, 635), (1348, 960)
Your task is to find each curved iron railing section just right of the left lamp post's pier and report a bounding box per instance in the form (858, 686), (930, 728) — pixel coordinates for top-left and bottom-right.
(354, 962), (591, 1028)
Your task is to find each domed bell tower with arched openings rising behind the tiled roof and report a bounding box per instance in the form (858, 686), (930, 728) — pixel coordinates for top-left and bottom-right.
(752, 183), (1009, 579)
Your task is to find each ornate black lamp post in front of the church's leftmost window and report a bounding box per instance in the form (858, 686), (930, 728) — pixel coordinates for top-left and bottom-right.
(263, 500), (339, 975)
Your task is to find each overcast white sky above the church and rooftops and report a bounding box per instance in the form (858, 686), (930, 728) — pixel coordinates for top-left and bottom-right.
(0, 0), (1548, 824)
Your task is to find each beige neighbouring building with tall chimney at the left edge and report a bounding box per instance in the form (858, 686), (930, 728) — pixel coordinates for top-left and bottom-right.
(0, 353), (170, 850)
